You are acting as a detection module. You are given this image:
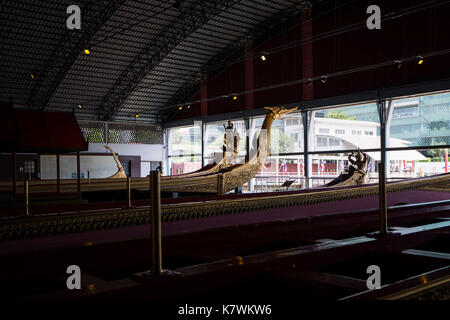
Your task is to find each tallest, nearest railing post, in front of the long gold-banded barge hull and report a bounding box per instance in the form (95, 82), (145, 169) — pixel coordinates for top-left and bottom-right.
(150, 171), (162, 275)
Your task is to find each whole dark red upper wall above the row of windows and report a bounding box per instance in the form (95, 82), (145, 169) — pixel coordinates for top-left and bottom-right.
(177, 0), (450, 119)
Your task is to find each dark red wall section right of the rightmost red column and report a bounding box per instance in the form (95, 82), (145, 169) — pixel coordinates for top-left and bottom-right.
(314, 1), (450, 99)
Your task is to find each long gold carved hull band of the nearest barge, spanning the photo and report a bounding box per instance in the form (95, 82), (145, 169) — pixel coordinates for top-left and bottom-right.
(0, 174), (450, 240)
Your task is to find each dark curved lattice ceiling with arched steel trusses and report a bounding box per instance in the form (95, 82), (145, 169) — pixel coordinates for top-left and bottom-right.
(0, 0), (324, 123)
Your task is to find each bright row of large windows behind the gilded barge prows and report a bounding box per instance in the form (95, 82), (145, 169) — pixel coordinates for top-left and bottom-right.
(164, 93), (450, 192)
